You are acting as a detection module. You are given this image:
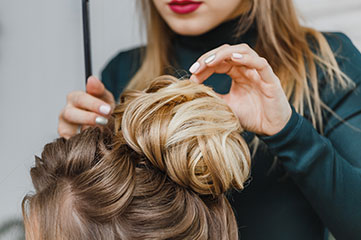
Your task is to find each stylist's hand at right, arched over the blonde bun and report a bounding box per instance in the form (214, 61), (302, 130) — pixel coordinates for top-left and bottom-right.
(190, 44), (292, 136)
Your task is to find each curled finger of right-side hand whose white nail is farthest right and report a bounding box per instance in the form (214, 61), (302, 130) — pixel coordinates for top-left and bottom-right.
(231, 52), (278, 83)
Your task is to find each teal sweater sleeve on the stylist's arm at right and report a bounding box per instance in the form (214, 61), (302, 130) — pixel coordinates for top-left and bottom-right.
(260, 32), (361, 239)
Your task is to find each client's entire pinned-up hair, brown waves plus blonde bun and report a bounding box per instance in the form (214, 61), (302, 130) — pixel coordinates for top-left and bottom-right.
(23, 76), (250, 240)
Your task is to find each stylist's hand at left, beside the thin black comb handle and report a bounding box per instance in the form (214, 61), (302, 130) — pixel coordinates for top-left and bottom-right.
(58, 76), (115, 139)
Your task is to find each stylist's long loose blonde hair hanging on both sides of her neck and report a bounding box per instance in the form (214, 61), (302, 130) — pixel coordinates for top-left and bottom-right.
(127, 0), (351, 132)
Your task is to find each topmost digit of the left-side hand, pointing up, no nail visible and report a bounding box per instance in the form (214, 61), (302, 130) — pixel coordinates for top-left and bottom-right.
(86, 76), (115, 106)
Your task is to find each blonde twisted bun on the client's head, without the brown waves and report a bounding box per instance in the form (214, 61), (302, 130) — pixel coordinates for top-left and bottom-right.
(115, 76), (250, 195)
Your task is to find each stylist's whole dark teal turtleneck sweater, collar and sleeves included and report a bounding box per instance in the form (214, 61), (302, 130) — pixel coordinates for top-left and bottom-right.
(102, 17), (361, 240)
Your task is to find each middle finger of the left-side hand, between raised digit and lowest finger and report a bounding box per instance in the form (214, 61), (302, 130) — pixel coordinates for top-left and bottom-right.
(67, 91), (112, 116)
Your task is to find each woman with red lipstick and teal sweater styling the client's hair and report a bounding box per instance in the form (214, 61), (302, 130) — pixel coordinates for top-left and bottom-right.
(59, 0), (361, 240)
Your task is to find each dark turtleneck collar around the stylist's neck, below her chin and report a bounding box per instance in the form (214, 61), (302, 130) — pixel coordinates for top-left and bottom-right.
(174, 17), (257, 52)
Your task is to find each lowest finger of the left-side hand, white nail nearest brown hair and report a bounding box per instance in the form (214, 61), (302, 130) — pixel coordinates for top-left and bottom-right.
(60, 107), (108, 126)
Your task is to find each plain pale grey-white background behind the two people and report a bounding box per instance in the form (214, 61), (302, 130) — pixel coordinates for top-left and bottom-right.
(0, 0), (361, 236)
